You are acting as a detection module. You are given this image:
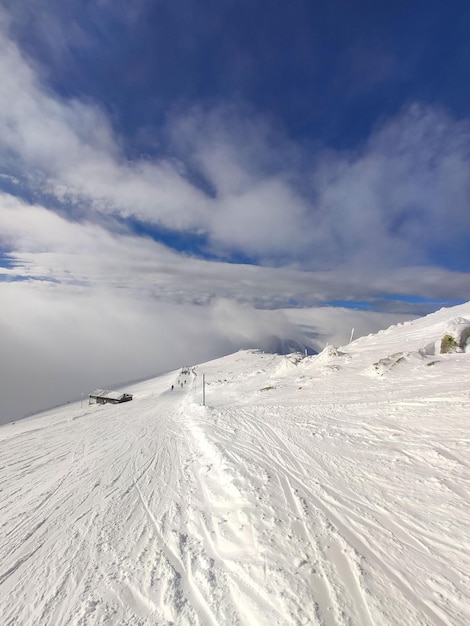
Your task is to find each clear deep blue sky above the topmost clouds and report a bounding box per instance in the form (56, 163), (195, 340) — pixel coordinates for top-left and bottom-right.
(6, 0), (470, 151)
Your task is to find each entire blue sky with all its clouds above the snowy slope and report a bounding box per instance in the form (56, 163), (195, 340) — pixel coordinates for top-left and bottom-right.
(0, 0), (470, 420)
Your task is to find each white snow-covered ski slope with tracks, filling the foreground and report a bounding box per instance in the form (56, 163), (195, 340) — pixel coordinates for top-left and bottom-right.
(0, 303), (470, 626)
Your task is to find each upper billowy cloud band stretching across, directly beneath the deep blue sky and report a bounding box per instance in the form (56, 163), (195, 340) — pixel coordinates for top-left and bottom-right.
(0, 18), (470, 268)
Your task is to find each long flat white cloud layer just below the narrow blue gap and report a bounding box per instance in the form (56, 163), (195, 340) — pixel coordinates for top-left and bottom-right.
(0, 194), (469, 308)
